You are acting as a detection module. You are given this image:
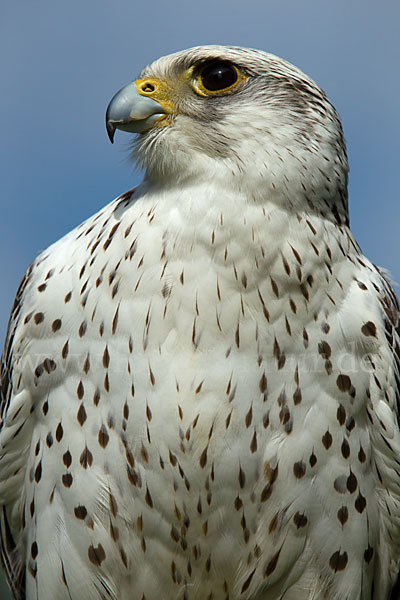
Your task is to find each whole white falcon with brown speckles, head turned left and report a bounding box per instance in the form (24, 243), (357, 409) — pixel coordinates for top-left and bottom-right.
(0, 46), (400, 600)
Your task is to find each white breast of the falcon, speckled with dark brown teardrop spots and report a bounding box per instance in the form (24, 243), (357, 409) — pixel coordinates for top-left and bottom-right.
(3, 188), (398, 600)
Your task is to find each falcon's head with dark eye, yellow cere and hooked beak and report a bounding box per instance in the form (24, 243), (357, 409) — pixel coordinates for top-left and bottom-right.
(106, 46), (348, 222)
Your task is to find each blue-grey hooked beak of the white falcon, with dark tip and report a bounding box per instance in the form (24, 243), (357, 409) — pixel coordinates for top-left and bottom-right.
(106, 83), (166, 143)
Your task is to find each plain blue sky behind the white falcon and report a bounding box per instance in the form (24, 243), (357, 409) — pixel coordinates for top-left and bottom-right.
(0, 0), (400, 600)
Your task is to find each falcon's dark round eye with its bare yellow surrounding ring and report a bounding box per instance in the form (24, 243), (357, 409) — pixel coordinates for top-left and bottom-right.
(193, 60), (246, 96)
